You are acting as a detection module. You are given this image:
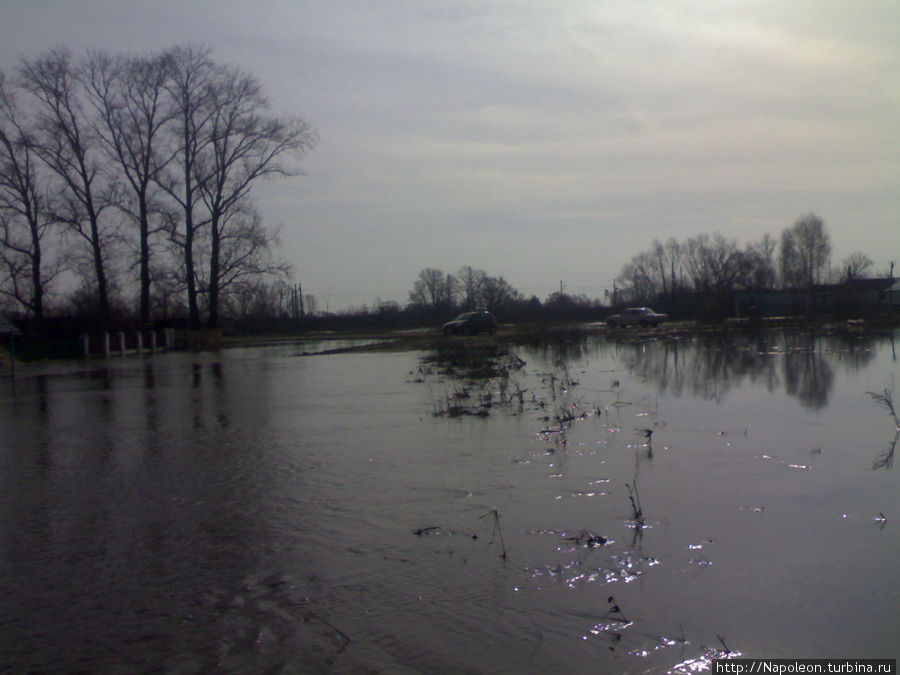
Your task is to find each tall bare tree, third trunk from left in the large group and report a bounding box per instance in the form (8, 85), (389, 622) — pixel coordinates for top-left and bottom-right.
(83, 52), (175, 323)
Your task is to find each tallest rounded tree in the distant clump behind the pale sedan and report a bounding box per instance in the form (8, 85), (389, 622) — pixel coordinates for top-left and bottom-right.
(781, 212), (831, 288)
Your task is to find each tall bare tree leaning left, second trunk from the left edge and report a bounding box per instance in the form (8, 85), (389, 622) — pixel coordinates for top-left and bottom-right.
(19, 48), (112, 321)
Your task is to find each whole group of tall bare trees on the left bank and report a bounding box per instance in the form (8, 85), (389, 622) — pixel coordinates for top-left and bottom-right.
(0, 45), (317, 327)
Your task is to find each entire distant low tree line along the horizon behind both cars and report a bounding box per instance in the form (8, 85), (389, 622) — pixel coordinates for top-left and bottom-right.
(221, 213), (888, 332)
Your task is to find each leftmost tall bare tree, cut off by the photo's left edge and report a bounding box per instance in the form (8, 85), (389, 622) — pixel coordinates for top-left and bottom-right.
(0, 73), (59, 319)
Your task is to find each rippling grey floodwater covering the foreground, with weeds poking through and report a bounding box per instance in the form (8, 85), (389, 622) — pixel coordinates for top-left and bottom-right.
(0, 332), (900, 673)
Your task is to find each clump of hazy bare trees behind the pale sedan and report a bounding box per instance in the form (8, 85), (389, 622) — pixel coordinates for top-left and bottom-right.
(617, 212), (873, 303)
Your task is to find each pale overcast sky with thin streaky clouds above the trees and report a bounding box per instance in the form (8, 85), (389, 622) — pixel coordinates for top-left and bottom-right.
(0, 0), (900, 311)
